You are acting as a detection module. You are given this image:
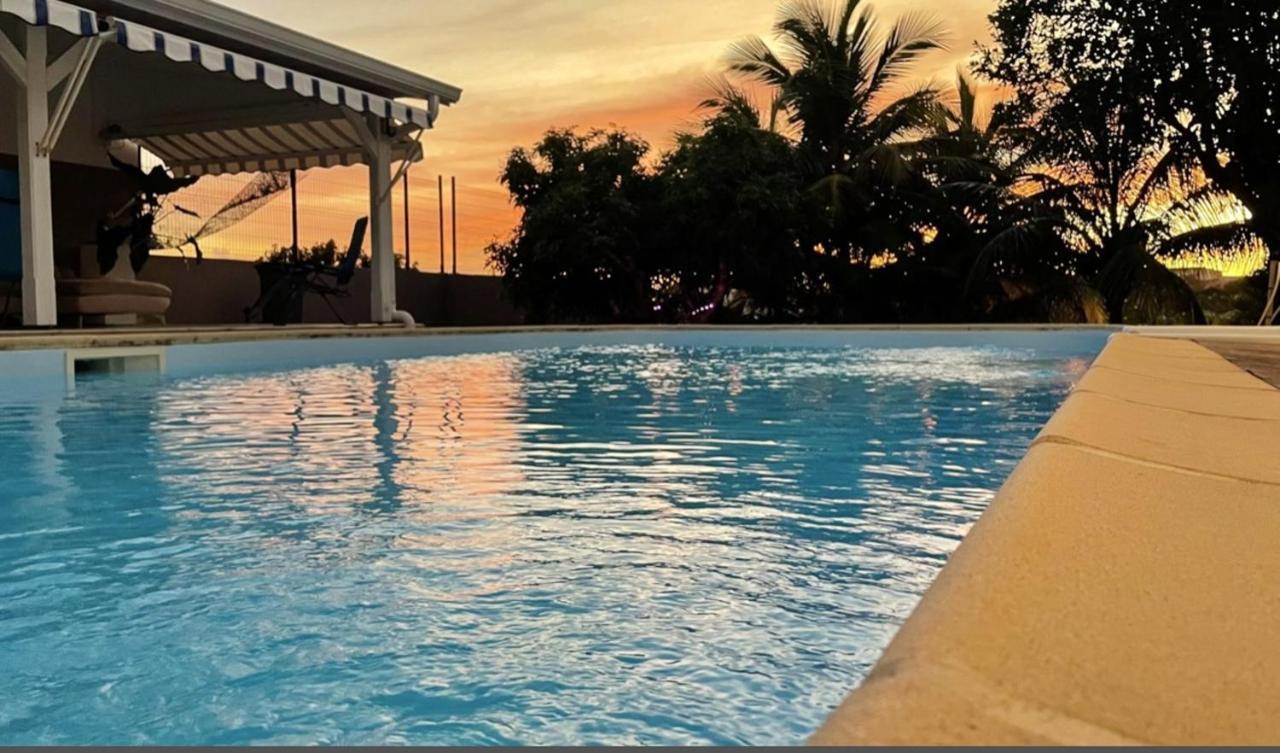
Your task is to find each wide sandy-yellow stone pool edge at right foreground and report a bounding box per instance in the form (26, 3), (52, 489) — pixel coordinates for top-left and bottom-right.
(812, 328), (1280, 745)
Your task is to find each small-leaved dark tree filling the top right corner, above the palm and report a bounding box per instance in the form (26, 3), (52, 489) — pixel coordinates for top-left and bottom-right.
(982, 0), (1280, 306)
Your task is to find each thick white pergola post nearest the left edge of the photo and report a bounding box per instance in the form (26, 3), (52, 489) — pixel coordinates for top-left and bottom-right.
(18, 27), (58, 327)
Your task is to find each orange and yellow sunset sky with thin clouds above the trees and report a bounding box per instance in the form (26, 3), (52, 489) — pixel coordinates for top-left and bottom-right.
(207, 0), (995, 273)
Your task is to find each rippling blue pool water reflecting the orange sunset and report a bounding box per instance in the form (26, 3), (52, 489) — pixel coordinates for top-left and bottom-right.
(0, 334), (1105, 744)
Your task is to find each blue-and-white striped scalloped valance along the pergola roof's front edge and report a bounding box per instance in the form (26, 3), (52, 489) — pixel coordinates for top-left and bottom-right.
(0, 0), (439, 128)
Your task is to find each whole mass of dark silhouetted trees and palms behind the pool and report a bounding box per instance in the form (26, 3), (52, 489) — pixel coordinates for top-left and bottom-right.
(489, 0), (1264, 323)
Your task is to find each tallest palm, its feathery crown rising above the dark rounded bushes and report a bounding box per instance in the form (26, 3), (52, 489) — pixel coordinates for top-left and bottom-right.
(728, 0), (943, 263)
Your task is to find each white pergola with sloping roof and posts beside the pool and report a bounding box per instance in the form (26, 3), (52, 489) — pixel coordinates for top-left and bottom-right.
(0, 0), (461, 327)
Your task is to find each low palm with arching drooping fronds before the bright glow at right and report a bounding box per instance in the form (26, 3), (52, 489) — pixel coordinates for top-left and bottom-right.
(970, 78), (1252, 324)
